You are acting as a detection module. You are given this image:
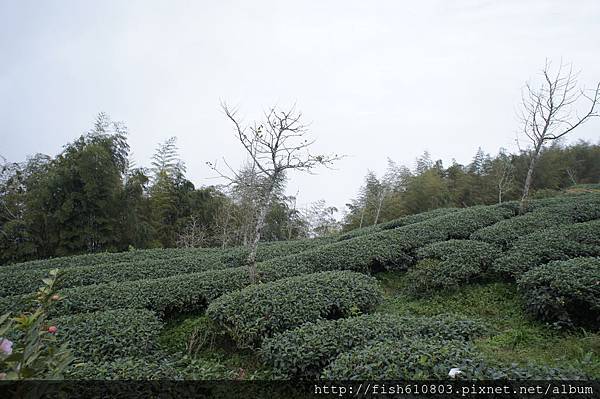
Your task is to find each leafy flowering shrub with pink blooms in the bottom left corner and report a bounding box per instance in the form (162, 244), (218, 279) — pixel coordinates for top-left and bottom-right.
(0, 270), (73, 380)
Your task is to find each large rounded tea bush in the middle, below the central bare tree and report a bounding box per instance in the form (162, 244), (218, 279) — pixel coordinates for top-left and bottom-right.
(207, 271), (382, 347)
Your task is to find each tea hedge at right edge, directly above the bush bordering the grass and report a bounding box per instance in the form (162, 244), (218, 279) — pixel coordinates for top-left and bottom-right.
(492, 220), (600, 277)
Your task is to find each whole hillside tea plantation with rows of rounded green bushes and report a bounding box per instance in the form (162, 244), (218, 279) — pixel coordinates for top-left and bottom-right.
(0, 192), (600, 379)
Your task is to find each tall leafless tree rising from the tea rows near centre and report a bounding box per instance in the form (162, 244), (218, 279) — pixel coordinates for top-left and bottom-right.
(209, 103), (341, 283)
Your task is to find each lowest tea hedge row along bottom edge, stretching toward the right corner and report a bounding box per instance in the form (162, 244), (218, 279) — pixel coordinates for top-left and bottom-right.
(322, 338), (587, 382)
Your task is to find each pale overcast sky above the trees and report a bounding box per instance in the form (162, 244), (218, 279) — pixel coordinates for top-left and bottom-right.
(0, 0), (600, 214)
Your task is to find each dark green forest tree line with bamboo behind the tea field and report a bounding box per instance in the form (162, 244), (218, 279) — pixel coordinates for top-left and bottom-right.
(0, 114), (600, 264)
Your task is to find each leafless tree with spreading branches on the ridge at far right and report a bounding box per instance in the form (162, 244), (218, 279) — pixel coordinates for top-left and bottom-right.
(521, 61), (600, 210)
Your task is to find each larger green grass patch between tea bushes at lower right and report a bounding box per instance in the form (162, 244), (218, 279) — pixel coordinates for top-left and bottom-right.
(378, 272), (600, 379)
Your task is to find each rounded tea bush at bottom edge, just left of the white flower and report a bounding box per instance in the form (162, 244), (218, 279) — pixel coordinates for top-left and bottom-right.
(322, 339), (476, 381)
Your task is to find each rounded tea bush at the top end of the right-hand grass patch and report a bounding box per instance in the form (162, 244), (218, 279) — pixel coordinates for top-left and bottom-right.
(407, 240), (501, 295)
